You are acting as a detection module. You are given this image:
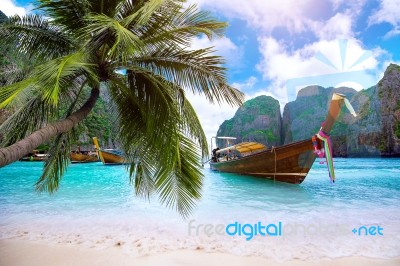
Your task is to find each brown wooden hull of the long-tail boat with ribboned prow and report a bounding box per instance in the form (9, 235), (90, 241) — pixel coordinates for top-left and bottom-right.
(210, 140), (316, 184)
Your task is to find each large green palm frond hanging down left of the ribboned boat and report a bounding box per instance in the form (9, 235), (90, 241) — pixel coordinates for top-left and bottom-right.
(110, 70), (206, 215)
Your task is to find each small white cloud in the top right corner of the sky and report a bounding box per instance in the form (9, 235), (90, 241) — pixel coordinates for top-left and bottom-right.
(368, 0), (400, 37)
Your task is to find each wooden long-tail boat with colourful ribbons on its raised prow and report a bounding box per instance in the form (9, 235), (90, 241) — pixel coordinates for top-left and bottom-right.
(210, 93), (355, 184)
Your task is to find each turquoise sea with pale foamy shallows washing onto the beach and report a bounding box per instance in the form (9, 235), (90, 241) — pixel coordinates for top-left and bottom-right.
(0, 158), (400, 261)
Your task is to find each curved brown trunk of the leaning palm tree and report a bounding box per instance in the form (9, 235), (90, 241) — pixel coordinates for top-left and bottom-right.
(0, 87), (100, 167)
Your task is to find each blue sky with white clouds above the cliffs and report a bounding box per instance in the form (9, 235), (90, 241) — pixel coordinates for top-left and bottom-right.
(0, 0), (400, 143)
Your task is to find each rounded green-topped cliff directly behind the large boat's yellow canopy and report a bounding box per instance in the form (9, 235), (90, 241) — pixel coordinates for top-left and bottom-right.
(217, 96), (281, 147)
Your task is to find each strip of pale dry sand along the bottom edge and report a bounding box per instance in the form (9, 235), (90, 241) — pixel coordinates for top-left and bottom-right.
(0, 240), (400, 266)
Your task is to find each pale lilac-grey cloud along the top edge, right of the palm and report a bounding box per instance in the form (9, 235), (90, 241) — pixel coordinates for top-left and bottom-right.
(192, 0), (366, 36)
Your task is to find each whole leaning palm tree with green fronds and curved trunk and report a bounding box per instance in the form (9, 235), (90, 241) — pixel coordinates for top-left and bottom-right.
(0, 0), (243, 215)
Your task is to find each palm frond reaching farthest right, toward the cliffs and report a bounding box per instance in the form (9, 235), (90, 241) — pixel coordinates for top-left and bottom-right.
(127, 48), (244, 106)
